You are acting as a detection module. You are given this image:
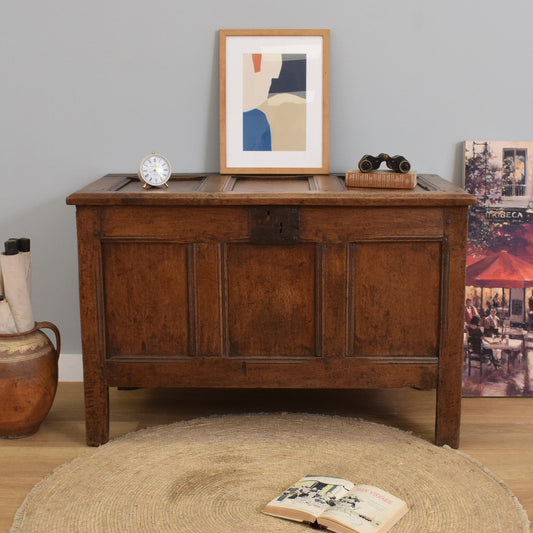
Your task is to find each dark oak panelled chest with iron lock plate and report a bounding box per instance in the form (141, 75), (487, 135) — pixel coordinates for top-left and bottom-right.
(67, 174), (473, 447)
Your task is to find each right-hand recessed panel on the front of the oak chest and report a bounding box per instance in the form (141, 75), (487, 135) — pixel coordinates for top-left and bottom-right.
(348, 242), (442, 357)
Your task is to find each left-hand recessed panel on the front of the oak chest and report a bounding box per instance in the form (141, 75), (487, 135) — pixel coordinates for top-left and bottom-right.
(102, 242), (191, 357)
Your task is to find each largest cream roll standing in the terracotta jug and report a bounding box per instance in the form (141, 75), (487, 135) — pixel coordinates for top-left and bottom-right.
(0, 254), (35, 333)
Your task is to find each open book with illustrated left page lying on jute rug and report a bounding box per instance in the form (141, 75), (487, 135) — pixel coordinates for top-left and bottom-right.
(263, 475), (408, 533)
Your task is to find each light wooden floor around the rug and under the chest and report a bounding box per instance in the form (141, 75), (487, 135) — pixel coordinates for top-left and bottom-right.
(0, 383), (533, 533)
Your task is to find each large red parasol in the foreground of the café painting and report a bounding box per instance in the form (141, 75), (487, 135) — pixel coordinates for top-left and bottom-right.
(466, 251), (533, 289)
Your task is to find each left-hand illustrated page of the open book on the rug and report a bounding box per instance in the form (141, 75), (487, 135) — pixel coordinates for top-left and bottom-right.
(264, 475), (354, 521)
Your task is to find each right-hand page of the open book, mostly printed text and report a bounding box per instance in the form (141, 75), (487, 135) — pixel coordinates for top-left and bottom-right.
(318, 485), (407, 533)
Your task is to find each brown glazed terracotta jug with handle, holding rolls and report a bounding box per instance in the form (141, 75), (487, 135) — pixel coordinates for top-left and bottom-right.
(0, 322), (61, 438)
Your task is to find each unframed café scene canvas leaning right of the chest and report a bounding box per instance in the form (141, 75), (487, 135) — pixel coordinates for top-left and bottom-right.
(463, 141), (533, 396)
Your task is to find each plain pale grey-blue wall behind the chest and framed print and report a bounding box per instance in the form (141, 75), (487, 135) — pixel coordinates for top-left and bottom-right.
(0, 0), (533, 354)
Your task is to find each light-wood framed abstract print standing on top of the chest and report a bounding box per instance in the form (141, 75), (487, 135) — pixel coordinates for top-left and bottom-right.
(219, 30), (329, 174)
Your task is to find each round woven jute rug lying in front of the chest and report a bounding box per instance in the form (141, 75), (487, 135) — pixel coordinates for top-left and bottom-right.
(11, 413), (529, 533)
